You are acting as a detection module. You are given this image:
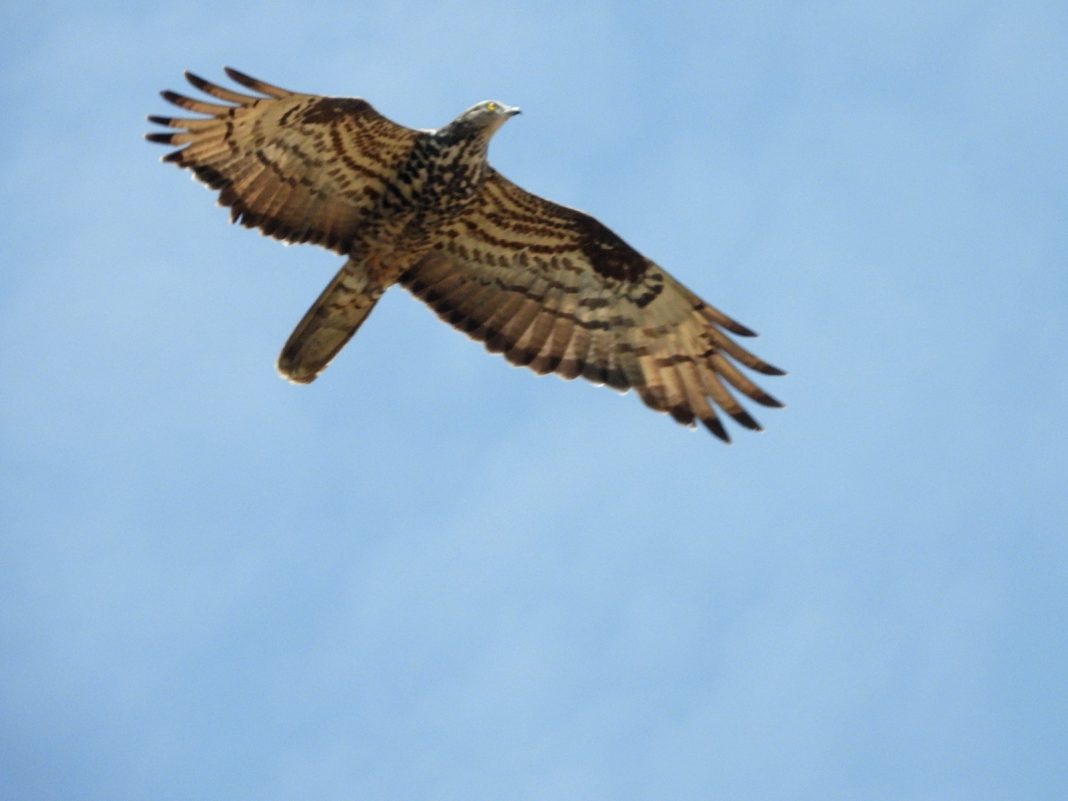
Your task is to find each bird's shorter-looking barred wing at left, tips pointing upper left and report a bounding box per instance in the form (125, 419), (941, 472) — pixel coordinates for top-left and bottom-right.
(146, 67), (420, 253)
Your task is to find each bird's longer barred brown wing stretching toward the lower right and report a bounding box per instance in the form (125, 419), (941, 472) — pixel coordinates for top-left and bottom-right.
(401, 172), (782, 441)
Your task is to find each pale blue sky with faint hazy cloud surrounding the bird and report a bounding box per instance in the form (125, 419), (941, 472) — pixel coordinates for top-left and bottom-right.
(0, 0), (1068, 801)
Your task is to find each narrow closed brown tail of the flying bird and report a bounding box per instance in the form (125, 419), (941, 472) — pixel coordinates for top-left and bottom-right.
(278, 258), (386, 383)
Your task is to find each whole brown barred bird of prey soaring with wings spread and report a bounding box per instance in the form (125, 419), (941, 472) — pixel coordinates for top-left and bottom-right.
(146, 67), (783, 441)
